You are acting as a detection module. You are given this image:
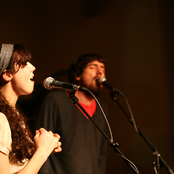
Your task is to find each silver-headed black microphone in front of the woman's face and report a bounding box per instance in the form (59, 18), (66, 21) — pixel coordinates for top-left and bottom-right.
(43, 77), (85, 91)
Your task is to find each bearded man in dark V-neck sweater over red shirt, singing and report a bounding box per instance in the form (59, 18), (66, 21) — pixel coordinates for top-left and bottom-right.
(36, 54), (108, 174)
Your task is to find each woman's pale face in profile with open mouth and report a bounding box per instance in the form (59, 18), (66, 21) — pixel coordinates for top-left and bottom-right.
(11, 62), (36, 97)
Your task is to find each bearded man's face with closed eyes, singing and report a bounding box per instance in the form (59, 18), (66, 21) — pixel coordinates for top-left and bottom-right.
(76, 60), (105, 95)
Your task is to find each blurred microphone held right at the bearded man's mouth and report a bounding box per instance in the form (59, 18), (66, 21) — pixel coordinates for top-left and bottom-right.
(97, 76), (123, 96)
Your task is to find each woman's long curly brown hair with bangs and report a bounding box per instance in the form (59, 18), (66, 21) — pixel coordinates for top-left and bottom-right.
(0, 44), (35, 163)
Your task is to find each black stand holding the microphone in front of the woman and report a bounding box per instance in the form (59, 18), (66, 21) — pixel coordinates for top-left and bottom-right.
(68, 91), (139, 174)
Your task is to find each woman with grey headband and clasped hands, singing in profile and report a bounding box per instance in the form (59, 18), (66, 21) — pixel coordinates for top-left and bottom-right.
(0, 44), (62, 174)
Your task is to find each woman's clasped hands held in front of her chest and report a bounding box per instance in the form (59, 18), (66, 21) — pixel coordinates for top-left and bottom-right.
(34, 128), (62, 158)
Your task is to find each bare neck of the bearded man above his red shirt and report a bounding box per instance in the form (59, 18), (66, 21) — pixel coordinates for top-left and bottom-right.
(75, 91), (94, 105)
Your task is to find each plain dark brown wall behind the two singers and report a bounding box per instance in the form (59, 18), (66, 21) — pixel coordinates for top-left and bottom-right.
(0, 0), (174, 174)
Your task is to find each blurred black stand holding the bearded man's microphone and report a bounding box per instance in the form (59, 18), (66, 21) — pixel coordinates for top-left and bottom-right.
(110, 88), (174, 174)
